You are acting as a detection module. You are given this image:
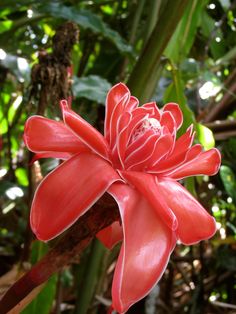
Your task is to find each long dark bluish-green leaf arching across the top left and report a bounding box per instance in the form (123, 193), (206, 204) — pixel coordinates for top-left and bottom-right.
(39, 2), (132, 53)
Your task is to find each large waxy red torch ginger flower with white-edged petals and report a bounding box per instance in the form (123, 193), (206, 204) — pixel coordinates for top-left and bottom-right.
(24, 84), (220, 313)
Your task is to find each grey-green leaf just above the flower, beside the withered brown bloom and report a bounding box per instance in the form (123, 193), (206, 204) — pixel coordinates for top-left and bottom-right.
(72, 75), (111, 104)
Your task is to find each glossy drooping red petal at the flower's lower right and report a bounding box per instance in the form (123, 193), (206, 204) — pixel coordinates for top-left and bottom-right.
(158, 179), (216, 245)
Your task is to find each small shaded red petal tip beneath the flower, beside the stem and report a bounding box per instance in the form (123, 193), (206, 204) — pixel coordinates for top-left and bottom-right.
(96, 221), (123, 249)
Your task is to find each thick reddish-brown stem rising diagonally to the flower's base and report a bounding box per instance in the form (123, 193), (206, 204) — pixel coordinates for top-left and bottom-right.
(0, 194), (119, 314)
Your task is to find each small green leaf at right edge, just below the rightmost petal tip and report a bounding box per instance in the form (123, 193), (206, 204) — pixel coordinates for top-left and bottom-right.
(220, 165), (236, 202)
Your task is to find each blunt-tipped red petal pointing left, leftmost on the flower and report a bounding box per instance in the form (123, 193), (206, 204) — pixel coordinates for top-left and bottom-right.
(24, 116), (85, 153)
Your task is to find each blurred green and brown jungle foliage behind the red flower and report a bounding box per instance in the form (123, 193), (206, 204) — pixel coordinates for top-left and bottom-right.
(0, 0), (236, 314)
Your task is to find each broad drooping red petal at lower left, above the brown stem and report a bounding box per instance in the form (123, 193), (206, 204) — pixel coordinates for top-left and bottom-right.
(30, 153), (120, 241)
